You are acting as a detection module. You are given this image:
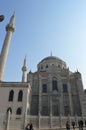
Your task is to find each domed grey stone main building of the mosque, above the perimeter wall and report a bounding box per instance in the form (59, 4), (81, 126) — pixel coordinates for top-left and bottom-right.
(27, 56), (86, 116)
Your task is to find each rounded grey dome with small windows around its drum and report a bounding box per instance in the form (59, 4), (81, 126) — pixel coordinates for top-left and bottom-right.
(37, 56), (66, 71)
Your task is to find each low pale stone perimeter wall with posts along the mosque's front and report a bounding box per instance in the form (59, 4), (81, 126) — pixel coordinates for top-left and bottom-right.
(0, 113), (86, 130)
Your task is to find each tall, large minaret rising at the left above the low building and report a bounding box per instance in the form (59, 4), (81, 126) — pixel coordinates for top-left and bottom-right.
(0, 13), (15, 81)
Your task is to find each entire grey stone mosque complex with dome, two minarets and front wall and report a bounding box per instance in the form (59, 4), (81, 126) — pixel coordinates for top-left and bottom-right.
(0, 14), (86, 130)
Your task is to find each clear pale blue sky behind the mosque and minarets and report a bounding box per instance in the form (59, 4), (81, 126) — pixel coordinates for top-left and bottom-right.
(0, 0), (86, 89)
